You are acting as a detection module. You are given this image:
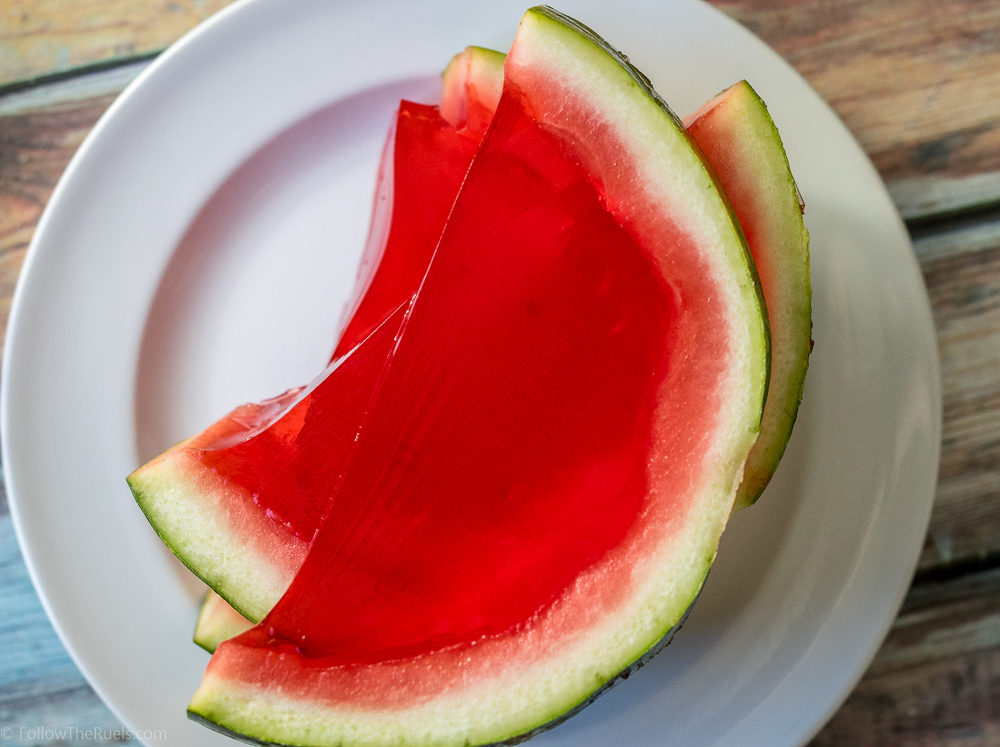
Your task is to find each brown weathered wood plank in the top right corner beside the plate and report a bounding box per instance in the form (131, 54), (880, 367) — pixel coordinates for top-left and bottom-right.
(711, 0), (1000, 217)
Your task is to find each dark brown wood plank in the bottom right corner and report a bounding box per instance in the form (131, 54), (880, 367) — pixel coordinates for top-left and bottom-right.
(812, 569), (1000, 747)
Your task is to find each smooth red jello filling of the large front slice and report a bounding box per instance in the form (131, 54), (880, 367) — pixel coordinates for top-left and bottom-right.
(240, 87), (673, 665)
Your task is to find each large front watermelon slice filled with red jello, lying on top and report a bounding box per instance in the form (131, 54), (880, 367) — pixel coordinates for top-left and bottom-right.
(190, 8), (768, 745)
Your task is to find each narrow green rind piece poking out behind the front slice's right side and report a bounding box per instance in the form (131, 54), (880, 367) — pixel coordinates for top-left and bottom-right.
(685, 81), (812, 510)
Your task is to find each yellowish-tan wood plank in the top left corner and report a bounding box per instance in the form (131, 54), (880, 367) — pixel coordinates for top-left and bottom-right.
(0, 0), (232, 86)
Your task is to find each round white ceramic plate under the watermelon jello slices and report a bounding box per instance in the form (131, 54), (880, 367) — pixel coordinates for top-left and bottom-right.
(2, 0), (940, 747)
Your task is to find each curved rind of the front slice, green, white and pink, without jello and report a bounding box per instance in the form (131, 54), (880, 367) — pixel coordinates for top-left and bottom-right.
(189, 7), (769, 747)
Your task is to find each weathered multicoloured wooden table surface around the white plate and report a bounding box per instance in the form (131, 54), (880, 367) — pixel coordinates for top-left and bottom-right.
(0, 0), (1000, 747)
